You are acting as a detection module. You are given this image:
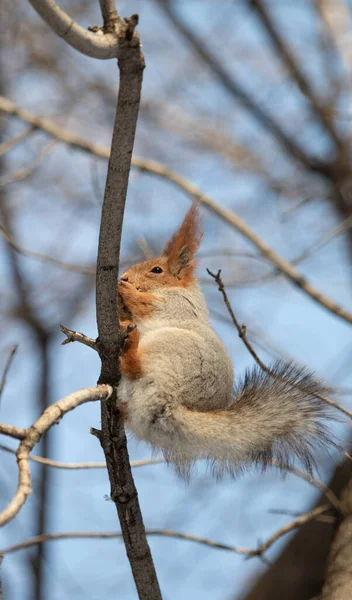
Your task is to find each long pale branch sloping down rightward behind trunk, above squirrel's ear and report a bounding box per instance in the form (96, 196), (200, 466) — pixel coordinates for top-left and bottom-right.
(0, 96), (352, 323)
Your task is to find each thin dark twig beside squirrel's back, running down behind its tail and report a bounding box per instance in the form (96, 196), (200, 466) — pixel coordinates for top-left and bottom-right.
(207, 269), (352, 418)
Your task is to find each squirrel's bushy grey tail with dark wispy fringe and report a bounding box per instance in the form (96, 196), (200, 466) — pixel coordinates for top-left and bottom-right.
(170, 361), (334, 474)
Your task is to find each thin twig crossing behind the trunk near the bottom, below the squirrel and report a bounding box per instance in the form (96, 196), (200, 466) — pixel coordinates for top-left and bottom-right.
(1, 505), (336, 557)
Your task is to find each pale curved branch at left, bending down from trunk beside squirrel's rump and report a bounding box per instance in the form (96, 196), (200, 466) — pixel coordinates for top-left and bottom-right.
(0, 385), (112, 526)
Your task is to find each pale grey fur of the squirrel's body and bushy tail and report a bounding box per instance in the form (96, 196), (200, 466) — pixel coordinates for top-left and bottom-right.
(119, 286), (331, 477)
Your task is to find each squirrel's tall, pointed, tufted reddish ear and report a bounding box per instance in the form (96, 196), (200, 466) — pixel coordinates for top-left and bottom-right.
(163, 202), (203, 276)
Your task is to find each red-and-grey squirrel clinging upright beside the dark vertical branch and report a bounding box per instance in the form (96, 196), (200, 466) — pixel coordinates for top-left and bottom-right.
(118, 203), (331, 478)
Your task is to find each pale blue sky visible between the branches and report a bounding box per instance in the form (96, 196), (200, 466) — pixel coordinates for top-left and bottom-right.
(0, 0), (352, 600)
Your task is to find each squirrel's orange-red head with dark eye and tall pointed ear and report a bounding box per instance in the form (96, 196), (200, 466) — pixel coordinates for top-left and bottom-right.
(120, 203), (202, 292)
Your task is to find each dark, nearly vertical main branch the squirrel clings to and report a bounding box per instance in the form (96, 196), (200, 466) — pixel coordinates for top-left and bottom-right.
(96, 2), (161, 600)
